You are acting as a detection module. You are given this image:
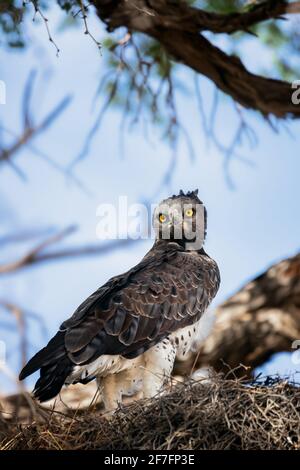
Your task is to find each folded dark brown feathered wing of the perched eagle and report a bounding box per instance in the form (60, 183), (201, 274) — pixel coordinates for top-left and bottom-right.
(61, 247), (219, 364)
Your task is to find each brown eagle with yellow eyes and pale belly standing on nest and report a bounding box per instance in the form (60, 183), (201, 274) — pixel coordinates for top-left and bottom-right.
(20, 191), (220, 410)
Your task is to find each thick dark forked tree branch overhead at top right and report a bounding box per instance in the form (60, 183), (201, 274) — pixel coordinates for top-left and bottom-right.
(93, 0), (300, 118)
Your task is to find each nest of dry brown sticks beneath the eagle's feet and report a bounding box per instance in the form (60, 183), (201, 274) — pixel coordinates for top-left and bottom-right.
(0, 377), (300, 450)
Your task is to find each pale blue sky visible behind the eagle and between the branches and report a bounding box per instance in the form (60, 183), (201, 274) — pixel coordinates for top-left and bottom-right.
(0, 4), (300, 390)
